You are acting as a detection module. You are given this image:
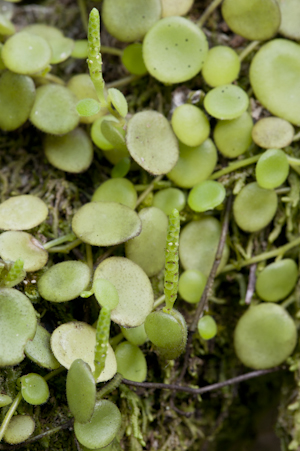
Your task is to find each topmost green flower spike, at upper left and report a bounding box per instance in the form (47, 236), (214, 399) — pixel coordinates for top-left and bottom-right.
(87, 8), (106, 106)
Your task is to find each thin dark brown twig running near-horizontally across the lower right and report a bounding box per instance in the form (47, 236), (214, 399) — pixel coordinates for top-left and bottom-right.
(122, 367), (283, 395)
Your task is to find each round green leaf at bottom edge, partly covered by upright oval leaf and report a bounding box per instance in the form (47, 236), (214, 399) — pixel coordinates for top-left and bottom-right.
(74, 399), (121, 449)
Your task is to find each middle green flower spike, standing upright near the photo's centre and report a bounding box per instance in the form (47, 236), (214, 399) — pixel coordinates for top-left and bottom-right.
(164, 208), (180, 313)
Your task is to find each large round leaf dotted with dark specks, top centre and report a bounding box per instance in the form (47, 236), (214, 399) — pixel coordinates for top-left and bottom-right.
(143, 16), (208, 84)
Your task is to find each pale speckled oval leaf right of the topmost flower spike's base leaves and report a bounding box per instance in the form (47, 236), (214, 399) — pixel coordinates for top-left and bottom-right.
(126, 111), (179, 175)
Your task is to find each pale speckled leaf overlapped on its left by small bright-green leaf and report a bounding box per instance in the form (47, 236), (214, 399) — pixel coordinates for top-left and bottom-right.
(94, 257), (154, 327)
